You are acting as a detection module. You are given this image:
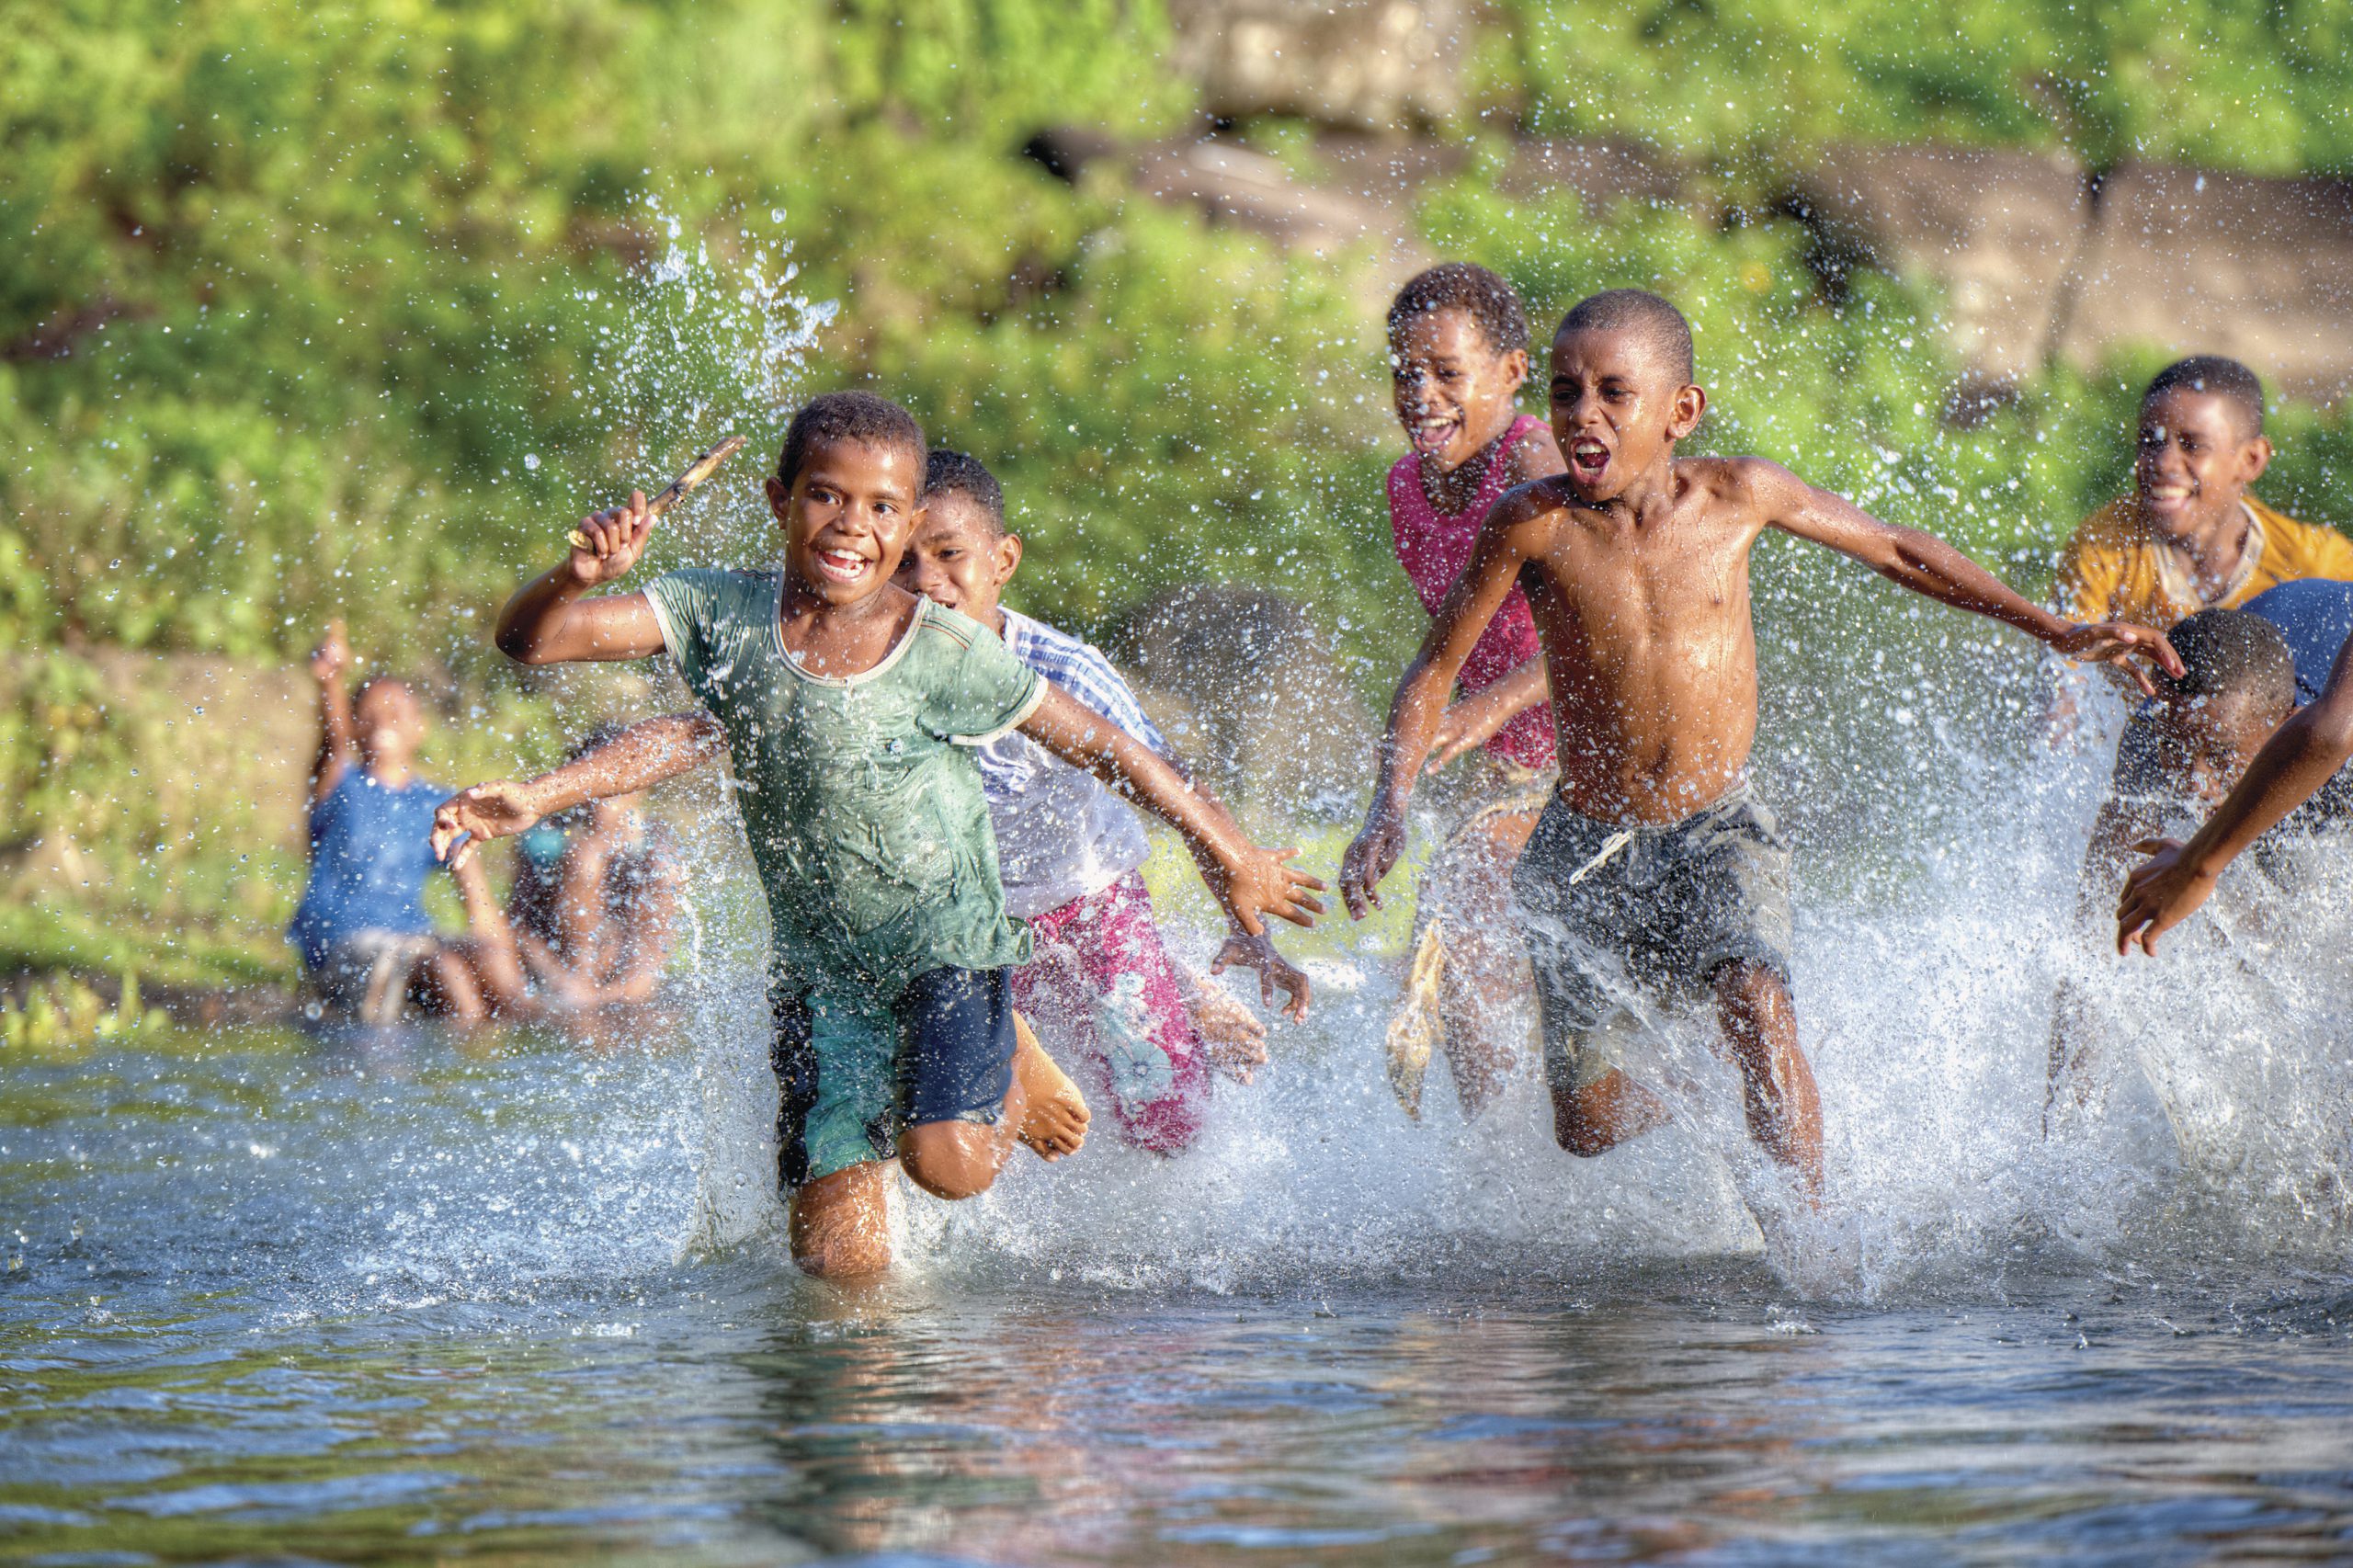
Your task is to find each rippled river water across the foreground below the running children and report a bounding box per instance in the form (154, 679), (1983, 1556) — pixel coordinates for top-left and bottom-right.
(14, 970), (2353, 1563)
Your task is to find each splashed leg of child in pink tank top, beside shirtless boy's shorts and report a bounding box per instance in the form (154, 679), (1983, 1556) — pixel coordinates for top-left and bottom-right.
(1421, 812), (1539, 1116)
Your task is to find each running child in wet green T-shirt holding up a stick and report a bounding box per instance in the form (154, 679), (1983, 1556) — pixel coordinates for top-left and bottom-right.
(433, 393), (1323, 1276)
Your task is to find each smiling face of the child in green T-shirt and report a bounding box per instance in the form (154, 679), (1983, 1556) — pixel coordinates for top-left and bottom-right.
(767, 440), (923, 605)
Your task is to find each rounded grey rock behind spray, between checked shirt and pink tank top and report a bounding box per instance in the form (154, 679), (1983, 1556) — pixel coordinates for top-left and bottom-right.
(1106, 584), (1379, 812)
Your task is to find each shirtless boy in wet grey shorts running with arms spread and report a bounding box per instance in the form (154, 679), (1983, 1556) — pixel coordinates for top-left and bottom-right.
(1341, 290), (2179, 1196)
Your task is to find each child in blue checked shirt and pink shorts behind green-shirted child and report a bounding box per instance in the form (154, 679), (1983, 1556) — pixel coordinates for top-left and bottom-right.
(899, 452), (1308, 1153)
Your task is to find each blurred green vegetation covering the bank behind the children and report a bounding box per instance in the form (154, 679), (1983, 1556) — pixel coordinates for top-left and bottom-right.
(0, 0), (2353, 980)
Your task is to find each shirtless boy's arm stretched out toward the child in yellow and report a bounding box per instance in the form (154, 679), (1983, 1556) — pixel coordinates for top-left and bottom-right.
(1759, 457), (2181, 697)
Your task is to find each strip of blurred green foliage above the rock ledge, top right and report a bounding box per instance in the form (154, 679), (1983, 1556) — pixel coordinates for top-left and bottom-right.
(1478, 0), (2353, 175)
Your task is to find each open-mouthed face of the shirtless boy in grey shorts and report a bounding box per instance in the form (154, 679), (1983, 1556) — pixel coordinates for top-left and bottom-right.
(1551, 327), (1709, 506)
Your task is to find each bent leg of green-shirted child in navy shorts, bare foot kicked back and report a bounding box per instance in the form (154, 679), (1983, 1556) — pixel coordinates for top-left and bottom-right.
(892, 968), (1085, 1200)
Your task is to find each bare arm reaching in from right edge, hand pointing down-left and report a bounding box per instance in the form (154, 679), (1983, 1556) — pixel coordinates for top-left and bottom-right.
(2115, 641), (2353, 959)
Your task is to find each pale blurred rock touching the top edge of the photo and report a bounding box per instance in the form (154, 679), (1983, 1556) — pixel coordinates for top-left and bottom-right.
(1169, 0), (1473, 130)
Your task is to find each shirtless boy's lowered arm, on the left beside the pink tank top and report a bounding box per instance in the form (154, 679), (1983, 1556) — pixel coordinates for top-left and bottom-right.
(1339, 490), (1553, 921)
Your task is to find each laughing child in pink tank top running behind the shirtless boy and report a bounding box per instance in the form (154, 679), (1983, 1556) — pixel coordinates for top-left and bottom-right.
(1388, 261), (1567, 1116)
